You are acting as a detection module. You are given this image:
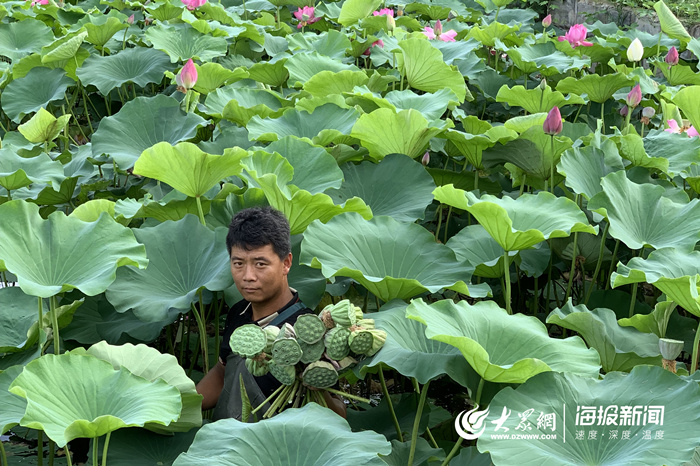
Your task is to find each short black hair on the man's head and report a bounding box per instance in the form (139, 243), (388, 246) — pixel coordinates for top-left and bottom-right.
(226, 206), (292, 260)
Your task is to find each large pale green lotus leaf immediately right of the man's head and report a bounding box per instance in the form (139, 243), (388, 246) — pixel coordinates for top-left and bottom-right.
(300, 213), (486, 301)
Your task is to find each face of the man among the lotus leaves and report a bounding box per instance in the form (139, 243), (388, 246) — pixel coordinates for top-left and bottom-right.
(231, 244), (292, 304)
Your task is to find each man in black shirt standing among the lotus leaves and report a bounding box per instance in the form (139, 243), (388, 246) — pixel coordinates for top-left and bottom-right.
(197, 207), (346, 420)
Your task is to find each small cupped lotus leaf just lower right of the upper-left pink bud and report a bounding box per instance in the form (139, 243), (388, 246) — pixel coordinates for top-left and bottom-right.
(219, 88), (283, 126)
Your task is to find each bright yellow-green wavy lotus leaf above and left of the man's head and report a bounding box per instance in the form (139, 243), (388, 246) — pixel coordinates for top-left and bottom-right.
(134, 142), (248, 197)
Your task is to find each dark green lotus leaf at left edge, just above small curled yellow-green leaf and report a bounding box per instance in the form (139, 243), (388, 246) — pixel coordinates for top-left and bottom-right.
(1, 68), (75, 123)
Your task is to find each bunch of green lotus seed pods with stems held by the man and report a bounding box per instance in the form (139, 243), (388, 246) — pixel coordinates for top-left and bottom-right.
(229, 299), (386, 418)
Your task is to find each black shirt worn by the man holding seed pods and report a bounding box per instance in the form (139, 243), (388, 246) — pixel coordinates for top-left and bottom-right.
(219, 291), (313, 396)
